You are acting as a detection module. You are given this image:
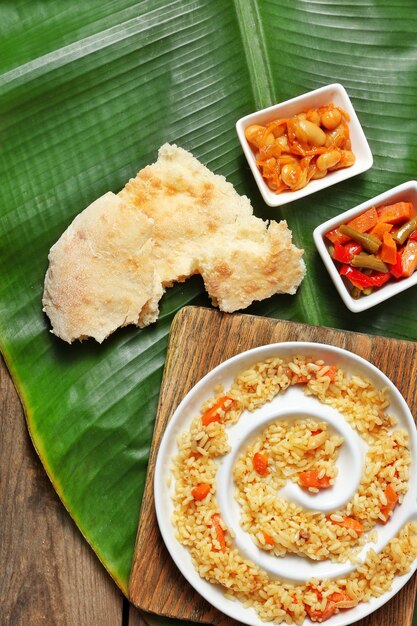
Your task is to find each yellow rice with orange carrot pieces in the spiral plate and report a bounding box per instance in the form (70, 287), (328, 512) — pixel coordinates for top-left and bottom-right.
(172, 356), (417, 624)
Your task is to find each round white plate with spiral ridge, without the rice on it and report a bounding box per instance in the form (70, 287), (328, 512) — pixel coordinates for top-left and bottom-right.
(154, 342), (417, 626)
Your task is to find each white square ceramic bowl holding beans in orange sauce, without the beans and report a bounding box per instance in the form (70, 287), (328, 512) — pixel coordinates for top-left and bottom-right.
(236, 83), (373, 206)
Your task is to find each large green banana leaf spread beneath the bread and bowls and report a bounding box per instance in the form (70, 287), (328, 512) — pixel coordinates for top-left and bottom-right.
(0, 0), (417, 608)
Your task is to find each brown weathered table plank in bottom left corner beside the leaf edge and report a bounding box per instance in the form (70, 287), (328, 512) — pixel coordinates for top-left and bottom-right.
(0, 360), (123, 626)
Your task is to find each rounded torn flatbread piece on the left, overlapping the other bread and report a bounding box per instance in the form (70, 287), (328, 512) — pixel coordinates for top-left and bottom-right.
(42, 192), (163, 343)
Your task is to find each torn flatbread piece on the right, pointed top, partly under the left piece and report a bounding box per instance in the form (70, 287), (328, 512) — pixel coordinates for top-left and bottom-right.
(119, 144), (305, 320)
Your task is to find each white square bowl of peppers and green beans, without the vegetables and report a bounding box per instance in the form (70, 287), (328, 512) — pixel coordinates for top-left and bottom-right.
(313, 180), (417, 313)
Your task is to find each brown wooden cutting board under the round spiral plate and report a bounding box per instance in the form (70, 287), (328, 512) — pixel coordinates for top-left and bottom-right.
(129, 307), (417, 626)
